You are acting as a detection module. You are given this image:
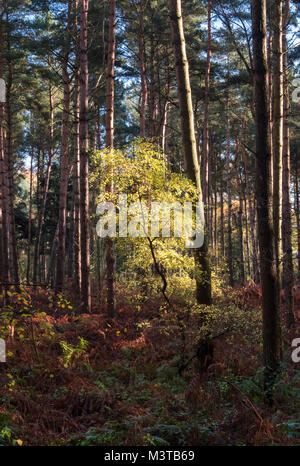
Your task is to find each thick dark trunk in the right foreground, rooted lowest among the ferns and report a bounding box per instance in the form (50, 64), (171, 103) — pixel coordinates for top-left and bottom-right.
(252, 0), (281, 404)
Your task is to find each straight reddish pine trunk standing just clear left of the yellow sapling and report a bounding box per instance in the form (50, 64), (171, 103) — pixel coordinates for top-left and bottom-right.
(79, 0), (91, 312)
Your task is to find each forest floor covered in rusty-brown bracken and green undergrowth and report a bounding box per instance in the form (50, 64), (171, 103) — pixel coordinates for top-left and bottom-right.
(0, 285), (300, 446)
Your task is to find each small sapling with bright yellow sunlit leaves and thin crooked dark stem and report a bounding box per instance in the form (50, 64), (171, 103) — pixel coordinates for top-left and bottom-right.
(90, 141), (198, 308)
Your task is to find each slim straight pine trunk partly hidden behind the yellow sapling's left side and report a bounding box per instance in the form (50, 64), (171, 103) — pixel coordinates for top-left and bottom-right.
(105, 0), (116, 317)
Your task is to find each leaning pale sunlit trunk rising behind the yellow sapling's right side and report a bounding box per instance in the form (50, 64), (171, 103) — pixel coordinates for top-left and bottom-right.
(170, 0), (211, 305)
